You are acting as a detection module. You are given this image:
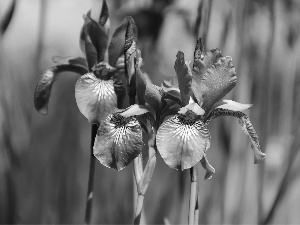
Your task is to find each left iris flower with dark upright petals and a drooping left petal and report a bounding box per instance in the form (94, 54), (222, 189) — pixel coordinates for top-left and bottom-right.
(34, 1), (128, 124)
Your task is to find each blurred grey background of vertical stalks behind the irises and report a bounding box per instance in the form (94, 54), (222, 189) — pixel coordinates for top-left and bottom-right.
(0, 0), (300, 224)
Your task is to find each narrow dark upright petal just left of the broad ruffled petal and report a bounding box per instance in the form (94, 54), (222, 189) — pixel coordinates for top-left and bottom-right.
(174, 51), (192, 106)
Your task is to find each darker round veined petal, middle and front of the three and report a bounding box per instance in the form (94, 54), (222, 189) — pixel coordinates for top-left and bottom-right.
(94, 113), (143, 171)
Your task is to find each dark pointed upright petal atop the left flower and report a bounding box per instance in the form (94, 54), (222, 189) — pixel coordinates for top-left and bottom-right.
(83, 15), (108, 62)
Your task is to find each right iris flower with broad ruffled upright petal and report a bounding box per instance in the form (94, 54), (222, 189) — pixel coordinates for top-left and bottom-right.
(156, 38), (265, 178)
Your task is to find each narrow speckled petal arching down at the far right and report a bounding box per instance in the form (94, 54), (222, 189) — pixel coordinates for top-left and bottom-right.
(205, 108), (266, 164)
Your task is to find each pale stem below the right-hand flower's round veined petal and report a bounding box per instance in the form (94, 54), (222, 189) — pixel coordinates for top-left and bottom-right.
(189, 166), (198, 225)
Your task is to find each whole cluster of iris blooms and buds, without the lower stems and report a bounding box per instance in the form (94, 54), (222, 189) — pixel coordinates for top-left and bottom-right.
(34, 1), (265, 178)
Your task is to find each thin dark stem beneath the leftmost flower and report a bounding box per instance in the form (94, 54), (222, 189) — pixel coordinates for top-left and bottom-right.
(84, 124), (98, 224)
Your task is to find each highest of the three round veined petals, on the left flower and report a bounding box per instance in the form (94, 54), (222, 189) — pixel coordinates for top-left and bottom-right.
(75, 73), (117, 124)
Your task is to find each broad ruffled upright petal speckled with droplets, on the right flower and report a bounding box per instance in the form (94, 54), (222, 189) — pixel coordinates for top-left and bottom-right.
(192, 39), (237, 111)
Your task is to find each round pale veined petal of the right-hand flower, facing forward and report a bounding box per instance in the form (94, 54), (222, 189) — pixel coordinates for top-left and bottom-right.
(156, 114), (210, 170)
